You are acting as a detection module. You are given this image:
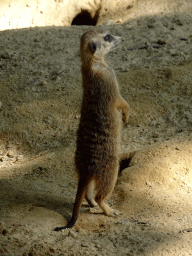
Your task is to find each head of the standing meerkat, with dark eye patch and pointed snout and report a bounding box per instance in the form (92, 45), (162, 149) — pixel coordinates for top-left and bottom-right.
(81, 29), (124, 62)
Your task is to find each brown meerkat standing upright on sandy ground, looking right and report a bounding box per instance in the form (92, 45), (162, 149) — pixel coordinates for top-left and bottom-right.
(55, 29), (129, 231)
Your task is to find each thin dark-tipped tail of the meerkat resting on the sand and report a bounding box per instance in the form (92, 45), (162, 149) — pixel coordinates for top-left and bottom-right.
(54, 178), (91, 231)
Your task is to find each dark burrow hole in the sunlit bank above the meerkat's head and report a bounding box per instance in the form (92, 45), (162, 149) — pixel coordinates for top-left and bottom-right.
(71, 10), (99, 26)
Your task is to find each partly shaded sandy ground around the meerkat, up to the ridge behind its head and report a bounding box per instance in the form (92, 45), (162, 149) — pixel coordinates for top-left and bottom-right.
(0, 9), (192, 256)
